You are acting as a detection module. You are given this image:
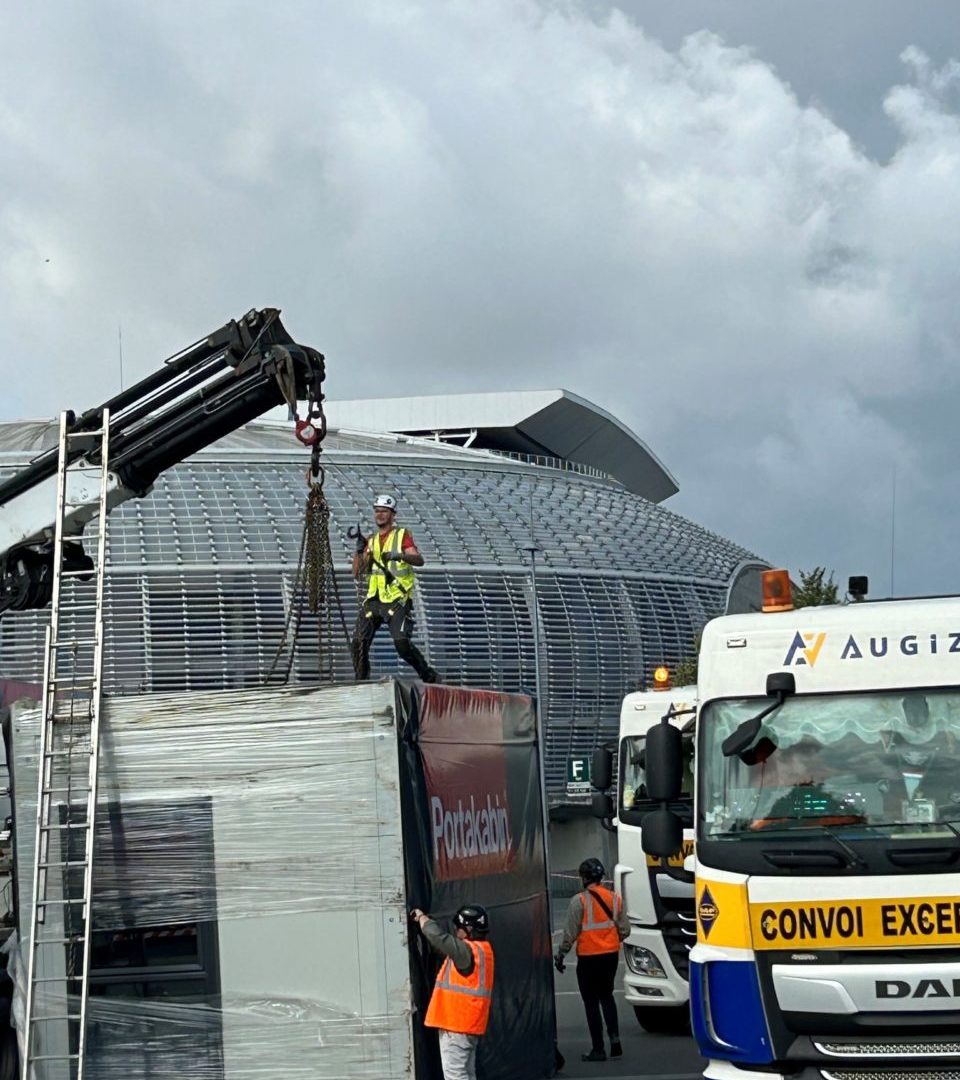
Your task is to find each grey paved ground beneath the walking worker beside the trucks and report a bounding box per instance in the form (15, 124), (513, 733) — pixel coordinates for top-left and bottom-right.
(556, 957), (704, 1080)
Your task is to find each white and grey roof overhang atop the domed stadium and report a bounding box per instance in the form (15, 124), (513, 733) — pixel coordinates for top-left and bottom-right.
(325, 390), (679, 502)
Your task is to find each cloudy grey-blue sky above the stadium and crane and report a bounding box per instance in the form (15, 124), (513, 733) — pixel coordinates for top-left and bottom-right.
(0, 0), (960, 595)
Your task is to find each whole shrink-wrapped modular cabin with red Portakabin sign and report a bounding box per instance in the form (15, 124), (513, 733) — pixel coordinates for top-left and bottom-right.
(8, 679), (555, 1080)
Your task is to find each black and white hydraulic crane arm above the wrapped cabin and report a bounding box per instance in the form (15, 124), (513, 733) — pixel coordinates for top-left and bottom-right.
(0, 308), (325, 612)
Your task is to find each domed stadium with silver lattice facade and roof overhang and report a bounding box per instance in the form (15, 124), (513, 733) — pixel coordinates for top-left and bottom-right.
(0, 391), (766, 802)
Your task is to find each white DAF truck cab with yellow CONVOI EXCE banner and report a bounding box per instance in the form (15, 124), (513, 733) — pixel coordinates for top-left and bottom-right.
(645, 585), (960, 1080)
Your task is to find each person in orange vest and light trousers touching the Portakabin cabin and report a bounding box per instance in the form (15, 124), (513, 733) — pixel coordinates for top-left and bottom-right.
(410, 904), (493, 1080)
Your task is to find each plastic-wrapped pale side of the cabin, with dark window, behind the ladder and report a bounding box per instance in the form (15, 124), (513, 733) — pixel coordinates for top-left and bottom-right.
(12, 681), (414, 1080)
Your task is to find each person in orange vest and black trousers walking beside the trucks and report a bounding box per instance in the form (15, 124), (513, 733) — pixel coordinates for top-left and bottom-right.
(554, 859), (630, 1062)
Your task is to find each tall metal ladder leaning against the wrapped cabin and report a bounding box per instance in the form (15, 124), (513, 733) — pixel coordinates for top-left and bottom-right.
(21, 409), (110, 1080)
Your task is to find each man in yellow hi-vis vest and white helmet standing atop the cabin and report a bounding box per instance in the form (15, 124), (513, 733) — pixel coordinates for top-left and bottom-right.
(351, 495), (438, 683)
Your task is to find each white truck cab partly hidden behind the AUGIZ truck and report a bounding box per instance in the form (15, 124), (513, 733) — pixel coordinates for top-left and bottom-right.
(613, 687), (697, 1034)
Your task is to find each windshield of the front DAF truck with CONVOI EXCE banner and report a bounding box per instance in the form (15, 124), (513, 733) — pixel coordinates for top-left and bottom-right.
(699, 690), (960, 839)
